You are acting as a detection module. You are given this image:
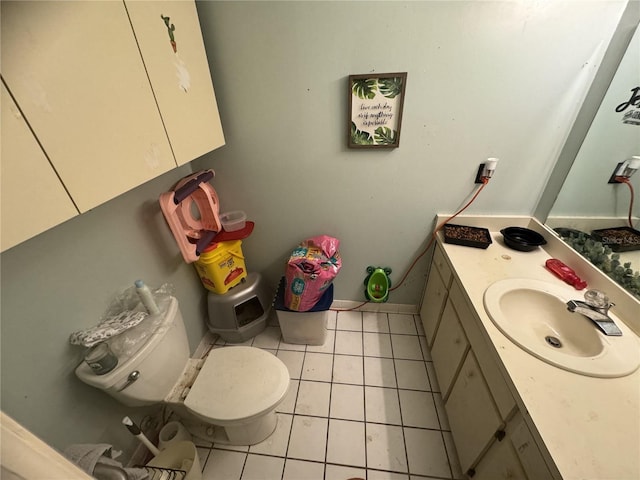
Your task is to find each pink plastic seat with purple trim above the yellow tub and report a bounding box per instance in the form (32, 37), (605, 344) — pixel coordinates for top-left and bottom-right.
(159, 170), (222, 263)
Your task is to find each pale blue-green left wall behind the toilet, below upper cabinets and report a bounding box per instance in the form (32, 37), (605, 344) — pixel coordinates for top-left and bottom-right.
(0, 167), (205, 451)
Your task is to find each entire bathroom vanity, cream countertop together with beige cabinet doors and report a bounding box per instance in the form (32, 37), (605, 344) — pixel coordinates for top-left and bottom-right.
(420, 215), (640, 480)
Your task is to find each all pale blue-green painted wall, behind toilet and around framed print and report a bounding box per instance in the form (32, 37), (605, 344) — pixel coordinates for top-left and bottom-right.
(1, 1), (624, 464)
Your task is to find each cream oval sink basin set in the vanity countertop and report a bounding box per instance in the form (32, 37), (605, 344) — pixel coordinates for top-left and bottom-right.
(484, 278), (640, 377)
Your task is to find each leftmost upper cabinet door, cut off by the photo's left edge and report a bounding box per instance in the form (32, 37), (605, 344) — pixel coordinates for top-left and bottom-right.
(0, 83), (78, 251)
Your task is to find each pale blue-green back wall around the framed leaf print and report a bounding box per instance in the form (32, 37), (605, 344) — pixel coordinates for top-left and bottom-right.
(196, 1), (624, 304)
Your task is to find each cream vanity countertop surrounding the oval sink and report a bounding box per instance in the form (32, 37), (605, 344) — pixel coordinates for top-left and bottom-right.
(441, 216), (640, 480)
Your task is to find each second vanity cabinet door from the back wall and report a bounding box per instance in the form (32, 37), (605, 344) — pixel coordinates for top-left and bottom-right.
(431, 299), (469, 399)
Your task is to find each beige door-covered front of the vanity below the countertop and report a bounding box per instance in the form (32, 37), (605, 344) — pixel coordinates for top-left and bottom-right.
(420, 245), (552, 480)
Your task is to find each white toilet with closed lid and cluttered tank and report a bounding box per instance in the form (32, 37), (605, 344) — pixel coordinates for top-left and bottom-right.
(76, 297), (290, 445)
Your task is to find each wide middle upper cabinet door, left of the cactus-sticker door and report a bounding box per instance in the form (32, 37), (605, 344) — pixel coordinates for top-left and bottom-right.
(0, 0), (176, 212)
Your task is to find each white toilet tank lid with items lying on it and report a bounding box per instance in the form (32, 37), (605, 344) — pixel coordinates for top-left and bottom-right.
(76, 297), (178, 389)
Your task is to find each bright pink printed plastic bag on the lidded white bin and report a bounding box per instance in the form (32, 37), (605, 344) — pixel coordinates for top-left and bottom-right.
(284, 235), (342, 312)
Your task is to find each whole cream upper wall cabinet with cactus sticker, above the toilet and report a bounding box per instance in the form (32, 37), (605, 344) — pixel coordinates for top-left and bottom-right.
(0, 1), (224, 251)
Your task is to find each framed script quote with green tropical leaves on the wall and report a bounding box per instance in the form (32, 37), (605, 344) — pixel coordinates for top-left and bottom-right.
(348, 72), (407, 148)
